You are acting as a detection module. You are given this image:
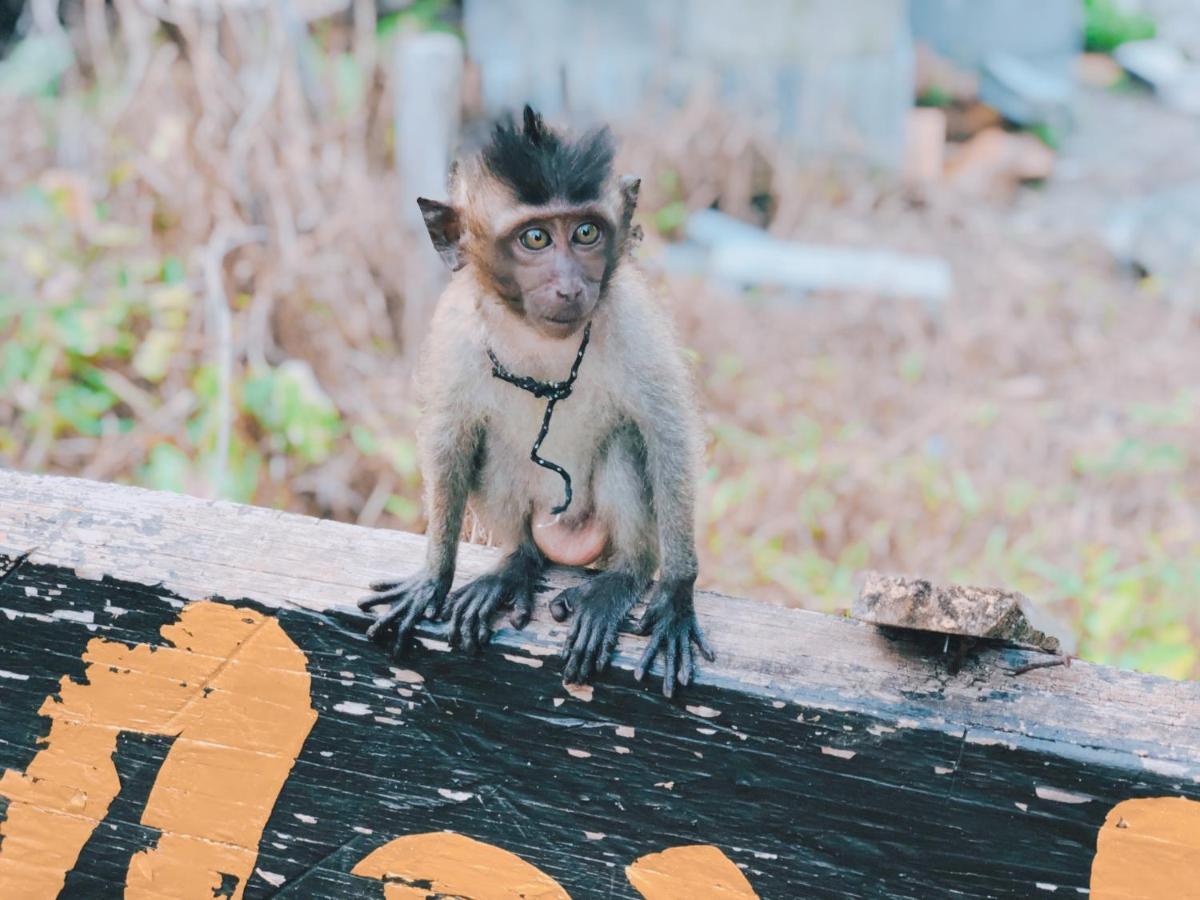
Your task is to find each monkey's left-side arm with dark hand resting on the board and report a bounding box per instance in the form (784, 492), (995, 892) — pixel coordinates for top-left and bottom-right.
(359, 402), (484, 655)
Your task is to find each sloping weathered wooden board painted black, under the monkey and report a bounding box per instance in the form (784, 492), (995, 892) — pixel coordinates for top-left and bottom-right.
(0, 473), (1200, 898)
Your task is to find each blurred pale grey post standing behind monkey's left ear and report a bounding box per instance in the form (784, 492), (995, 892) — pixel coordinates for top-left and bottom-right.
(395, 32), (463, 354)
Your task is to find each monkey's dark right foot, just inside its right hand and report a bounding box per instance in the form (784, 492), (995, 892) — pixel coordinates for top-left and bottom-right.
(550, 571), (637, 684)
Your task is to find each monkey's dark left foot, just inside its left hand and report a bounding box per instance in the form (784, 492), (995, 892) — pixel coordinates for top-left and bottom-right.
(442, 528), (546, 653)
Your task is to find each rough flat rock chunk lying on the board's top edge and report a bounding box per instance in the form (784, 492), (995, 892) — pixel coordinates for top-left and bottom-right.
(853, 572), (1061, 653)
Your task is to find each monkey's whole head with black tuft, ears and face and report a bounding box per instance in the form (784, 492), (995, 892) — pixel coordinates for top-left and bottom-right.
(416, 107), (641, 337)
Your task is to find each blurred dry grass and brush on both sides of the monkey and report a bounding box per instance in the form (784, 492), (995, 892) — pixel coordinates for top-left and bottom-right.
(0, 4), (1200, 676)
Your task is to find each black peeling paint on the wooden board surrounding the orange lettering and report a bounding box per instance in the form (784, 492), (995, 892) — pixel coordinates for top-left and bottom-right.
(0, 559), (1200, 899)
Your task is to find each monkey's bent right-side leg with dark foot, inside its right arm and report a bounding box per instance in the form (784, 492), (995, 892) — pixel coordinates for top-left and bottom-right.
(550, 426), (656, 683)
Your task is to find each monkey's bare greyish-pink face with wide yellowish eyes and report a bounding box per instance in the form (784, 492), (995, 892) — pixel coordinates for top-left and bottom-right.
(493, 209), (613, 337)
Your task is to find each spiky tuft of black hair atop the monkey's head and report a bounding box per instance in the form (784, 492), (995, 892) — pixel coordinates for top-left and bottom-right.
(482, 106), (616, 206)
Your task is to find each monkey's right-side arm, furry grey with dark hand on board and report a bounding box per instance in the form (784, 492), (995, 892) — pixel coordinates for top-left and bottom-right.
(634, 352), (715, 697)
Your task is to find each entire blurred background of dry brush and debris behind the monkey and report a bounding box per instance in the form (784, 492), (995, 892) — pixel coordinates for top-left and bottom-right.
(0, 0), (1200, 678)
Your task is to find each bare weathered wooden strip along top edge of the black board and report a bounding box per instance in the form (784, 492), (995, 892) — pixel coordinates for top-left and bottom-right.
(0, 472), (1200, 784)
